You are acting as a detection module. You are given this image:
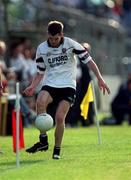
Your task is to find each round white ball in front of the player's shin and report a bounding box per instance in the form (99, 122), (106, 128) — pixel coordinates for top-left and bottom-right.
(35, 113), (53, 132)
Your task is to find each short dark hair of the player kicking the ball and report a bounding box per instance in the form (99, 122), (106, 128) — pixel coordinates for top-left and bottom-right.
(48, 21), (64, 36)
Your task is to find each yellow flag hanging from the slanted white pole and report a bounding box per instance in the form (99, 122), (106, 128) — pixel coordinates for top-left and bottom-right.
(80, 83), (94, 120)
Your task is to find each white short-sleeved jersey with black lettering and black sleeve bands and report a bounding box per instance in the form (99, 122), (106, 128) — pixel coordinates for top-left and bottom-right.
(36, 37), (92, 89)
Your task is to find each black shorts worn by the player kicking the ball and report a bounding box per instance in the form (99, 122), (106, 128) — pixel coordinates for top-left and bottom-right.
(41, 86), (76, 105)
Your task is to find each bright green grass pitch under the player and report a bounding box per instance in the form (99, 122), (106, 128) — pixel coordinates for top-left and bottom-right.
(0, 125), (131, 180)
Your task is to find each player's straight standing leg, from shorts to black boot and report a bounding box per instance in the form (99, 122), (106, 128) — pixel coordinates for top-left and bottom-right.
(52, 100), (70, 159)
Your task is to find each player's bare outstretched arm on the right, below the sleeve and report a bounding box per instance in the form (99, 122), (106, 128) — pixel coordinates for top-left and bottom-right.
(87, 59), (110, 94)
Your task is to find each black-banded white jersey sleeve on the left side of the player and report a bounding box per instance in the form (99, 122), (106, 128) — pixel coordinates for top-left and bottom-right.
(35, 47), (46, 74)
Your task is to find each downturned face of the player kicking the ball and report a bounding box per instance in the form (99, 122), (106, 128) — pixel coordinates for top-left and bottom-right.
(48, 33), (63, 47)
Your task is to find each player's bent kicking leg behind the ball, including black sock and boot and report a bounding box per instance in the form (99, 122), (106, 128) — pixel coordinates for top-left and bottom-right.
(26, 90), (53, 153)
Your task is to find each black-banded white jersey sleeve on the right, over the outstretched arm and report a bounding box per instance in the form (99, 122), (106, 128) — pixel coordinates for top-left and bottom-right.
(71, 40), (92, 64)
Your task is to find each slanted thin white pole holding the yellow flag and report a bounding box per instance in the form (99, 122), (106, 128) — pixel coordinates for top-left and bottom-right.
(91, 80), (102, 144)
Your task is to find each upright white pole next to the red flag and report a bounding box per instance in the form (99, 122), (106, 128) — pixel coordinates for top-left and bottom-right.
(15, 82), (20, 167)
